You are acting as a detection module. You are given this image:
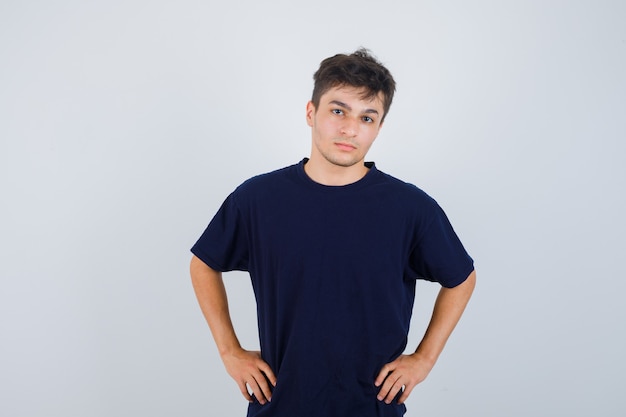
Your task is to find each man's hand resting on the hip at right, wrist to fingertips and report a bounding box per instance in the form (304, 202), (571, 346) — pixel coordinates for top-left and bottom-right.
(374, 353), (434, 404)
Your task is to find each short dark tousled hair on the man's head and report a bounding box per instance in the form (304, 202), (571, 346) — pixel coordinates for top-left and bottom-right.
(311, 48), (396, 122)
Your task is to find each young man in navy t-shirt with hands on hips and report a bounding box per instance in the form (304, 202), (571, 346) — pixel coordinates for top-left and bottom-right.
(191, 50), (475, 417)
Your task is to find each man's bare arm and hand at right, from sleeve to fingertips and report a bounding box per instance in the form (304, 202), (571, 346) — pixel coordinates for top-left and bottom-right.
(374, 271), (476, 404)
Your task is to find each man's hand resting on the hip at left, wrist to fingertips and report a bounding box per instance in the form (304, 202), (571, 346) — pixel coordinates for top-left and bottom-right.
(222, 349), (276, 404)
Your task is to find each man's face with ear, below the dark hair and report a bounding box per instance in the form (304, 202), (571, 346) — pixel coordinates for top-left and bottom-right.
(306, 87), (383, 168)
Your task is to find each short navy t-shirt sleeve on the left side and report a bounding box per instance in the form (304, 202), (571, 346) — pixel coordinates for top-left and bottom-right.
(191, 193), (249, 272)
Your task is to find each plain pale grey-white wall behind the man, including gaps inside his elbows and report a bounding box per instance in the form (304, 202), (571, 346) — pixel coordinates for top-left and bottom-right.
(0, 0), (626, 417)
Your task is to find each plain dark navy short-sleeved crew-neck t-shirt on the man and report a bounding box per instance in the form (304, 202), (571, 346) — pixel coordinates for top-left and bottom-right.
(192, 159), (473, 417)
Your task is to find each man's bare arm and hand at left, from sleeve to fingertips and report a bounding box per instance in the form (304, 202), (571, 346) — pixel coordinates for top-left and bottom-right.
(190, 256), (276, 404)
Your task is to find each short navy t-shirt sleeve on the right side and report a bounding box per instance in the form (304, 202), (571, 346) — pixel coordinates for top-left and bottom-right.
(411, 203), (474, 288)
